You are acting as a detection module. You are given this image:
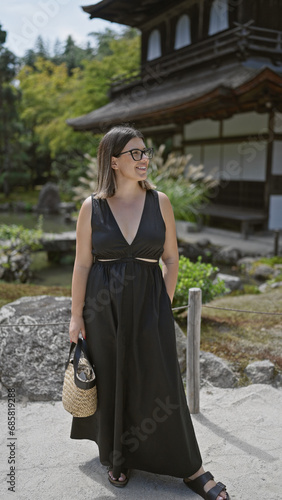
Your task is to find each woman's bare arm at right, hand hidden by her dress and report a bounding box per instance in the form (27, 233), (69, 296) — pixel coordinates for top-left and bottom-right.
(158, 192), (179, 302)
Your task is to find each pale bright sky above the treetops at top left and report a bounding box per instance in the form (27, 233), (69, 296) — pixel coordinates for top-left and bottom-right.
(0, 0), (123, 57)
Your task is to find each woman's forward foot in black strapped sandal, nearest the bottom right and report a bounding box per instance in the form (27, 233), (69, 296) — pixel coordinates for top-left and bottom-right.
(184, 467), (230, 500)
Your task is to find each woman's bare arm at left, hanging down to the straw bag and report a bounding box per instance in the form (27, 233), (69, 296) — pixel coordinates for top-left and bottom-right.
(69, 196), (93, 343)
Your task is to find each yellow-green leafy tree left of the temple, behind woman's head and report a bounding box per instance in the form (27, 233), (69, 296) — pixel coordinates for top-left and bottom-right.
(18, 28), (140, 192)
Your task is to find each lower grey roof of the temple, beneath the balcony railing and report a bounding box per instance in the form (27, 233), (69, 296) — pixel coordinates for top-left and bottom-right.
(67, 62), (282, 133)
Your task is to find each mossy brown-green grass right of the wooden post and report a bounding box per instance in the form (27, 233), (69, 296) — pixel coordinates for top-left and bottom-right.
(175, 289), (282, 384)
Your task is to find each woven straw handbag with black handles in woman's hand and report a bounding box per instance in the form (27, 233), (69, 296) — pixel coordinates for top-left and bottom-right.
(62, 337), (97, 417)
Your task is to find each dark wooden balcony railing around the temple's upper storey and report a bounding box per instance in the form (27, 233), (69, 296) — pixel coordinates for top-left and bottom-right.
(111, 21), (282, 98)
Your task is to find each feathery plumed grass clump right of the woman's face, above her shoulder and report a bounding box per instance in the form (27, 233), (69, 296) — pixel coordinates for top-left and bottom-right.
(150, 145), (217, 222)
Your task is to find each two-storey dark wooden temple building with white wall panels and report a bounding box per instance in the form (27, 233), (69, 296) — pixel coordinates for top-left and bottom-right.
(68, 0), (282, 236)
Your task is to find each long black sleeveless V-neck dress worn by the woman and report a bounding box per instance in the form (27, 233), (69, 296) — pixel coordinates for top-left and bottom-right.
(71, 190), (202, 478)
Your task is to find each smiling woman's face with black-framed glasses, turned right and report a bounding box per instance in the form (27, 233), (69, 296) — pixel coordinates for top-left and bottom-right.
(112, 137), (149, 181)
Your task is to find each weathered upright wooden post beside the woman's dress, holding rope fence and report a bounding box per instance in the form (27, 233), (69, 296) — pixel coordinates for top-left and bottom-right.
(186, 288), (202, 413)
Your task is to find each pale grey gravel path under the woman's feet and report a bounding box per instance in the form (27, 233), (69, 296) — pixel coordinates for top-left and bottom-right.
(0, 385), (282, 500)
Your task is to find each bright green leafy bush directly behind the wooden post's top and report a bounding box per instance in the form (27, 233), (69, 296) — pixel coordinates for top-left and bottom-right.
(173, 256), (226, 307)
